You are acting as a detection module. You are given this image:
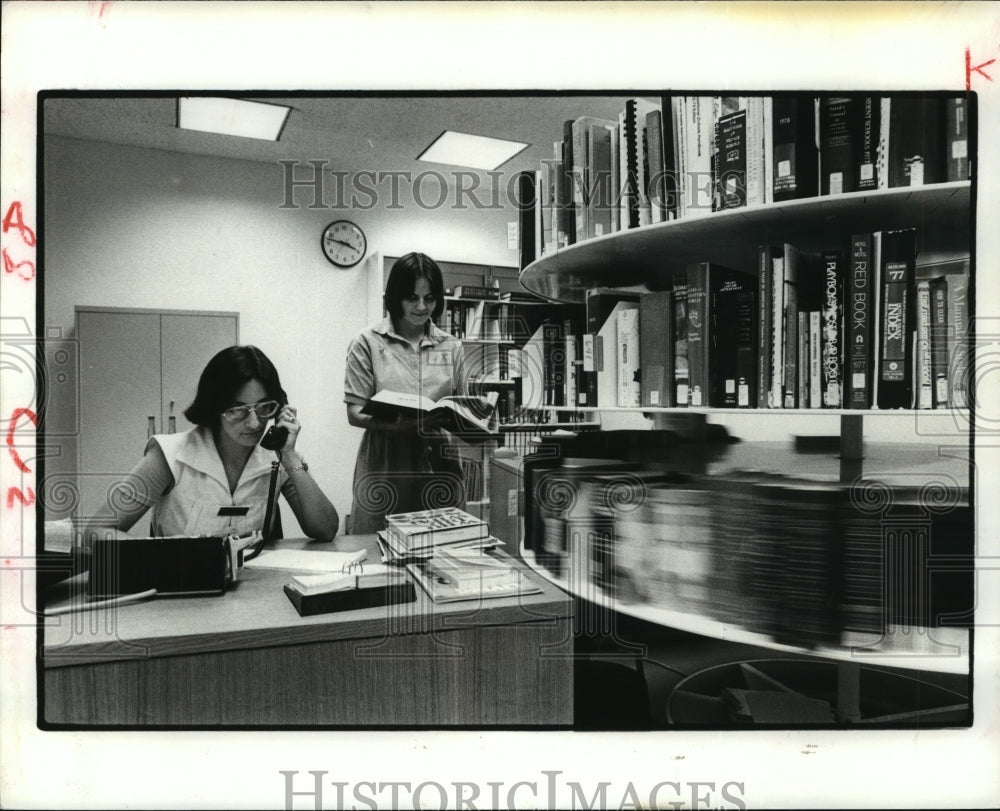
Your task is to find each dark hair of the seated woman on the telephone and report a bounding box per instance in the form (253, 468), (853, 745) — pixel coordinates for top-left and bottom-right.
(184, 346), (288, 428)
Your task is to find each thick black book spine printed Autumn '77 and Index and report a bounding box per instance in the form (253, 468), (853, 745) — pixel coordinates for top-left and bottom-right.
(878, 228), (916, 408)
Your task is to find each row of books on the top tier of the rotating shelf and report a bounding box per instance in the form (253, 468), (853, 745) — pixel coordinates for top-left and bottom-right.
(518, 93), (971, 268)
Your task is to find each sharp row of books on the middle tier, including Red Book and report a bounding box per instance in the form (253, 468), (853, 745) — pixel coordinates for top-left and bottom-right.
(507, 229), (971, 409)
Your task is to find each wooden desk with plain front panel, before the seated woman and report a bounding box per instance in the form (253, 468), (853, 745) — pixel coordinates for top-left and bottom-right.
(39, 536), (573, 727)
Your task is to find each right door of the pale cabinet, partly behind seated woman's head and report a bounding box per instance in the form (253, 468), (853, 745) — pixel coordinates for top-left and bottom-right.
(157, 313), (237, 433)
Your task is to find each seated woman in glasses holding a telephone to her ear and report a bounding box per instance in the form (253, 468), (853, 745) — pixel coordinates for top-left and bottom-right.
(103, 346), (339, 541)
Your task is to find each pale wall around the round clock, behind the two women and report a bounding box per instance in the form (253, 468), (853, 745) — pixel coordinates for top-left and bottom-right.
(42, 136), (516, 530)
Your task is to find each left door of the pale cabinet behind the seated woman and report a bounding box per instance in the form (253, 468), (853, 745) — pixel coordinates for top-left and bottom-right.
(77, 311), (162, 515)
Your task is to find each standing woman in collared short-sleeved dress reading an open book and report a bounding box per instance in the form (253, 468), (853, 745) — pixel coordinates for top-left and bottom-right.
(344, 253), (465, 534)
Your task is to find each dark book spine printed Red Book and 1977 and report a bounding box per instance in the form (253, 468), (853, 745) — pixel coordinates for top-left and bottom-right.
(844, 234), (873, 408)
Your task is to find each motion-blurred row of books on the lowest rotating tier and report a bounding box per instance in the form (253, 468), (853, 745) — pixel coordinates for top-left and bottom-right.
(526, 460), (974, 646)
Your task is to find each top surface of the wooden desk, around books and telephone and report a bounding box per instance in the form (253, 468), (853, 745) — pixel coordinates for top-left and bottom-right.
(43, 535), (572, 667)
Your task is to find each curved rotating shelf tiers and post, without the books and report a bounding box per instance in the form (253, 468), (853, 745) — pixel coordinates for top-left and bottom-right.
(521, 181), (973, 712)
